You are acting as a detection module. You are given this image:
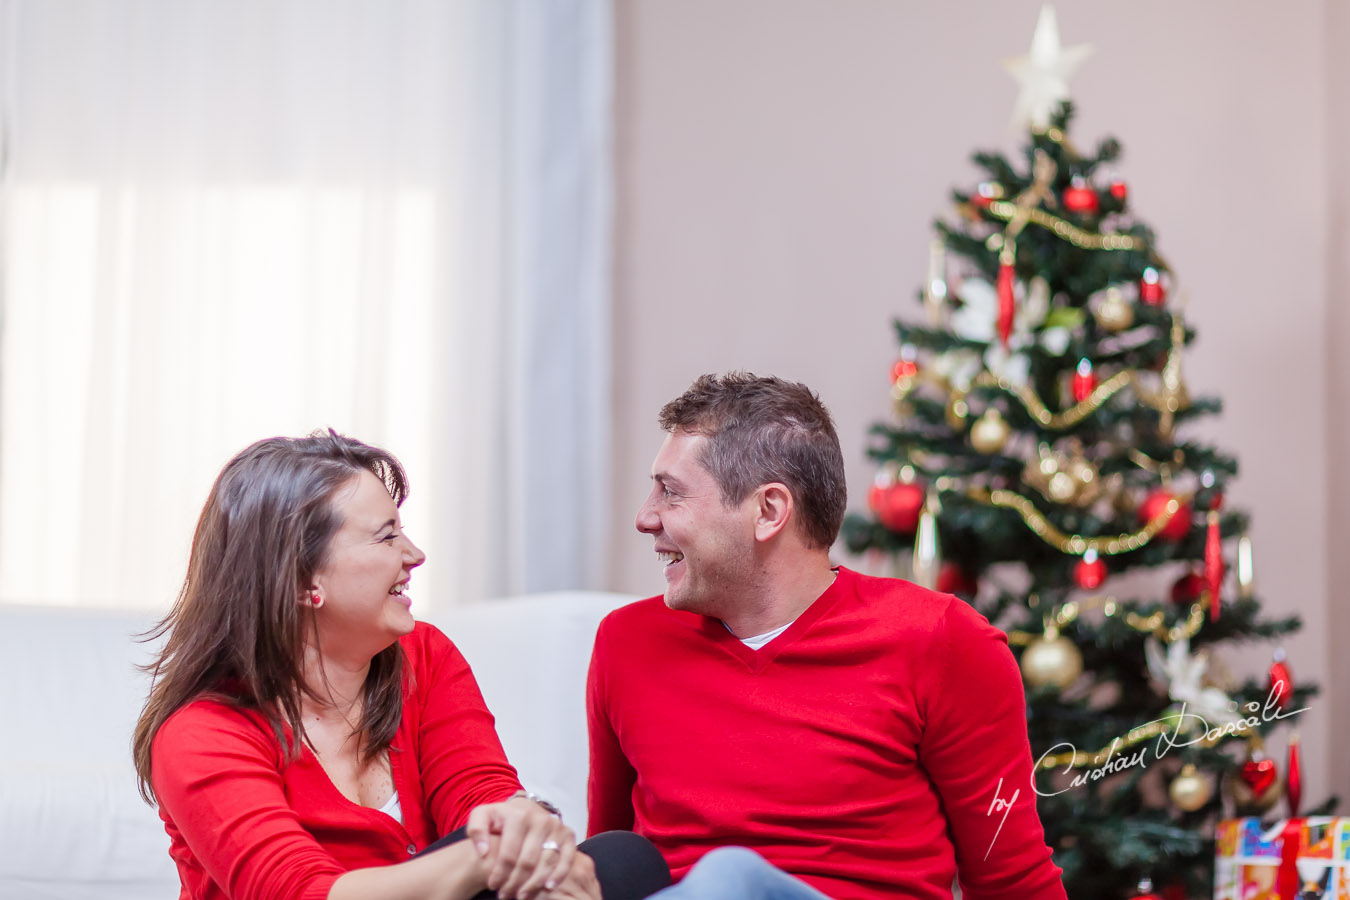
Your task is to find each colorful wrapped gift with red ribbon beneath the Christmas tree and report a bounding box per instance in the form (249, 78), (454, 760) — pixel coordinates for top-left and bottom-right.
(1214, 816), (1350, 900)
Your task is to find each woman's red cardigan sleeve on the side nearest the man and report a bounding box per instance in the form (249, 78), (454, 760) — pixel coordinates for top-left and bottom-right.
(412, 625), (521, 835)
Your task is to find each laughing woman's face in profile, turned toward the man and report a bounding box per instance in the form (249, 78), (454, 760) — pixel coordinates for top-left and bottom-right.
(305, 471), (427, 658)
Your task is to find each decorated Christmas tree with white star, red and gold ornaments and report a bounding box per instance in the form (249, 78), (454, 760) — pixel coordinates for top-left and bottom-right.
(844, 13), (1331, 900)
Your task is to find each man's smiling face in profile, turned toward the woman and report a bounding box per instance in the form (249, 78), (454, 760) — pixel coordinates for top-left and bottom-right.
(635, 432), (756, 618)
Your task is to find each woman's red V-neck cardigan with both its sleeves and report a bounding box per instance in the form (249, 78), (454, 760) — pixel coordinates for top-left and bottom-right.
(151, 623), (520, 900)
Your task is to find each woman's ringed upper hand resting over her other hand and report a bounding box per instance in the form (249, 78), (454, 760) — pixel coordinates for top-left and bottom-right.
(466, 797), (577, 900)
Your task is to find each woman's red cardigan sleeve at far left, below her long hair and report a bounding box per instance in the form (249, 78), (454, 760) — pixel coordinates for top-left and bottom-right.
(150, 700), (346, 900)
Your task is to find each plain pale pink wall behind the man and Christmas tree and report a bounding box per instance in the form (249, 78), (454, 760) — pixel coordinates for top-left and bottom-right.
(610, 0), (1350, 797)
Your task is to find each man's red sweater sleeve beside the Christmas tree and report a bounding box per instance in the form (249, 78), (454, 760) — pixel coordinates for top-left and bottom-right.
(919, 598), (1065, 900)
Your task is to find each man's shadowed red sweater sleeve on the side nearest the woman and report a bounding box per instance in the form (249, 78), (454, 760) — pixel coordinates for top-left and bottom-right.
(586, 619), (637, 835)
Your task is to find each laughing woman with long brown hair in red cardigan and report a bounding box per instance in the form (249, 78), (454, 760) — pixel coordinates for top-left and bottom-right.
(134, 430), (668, 900)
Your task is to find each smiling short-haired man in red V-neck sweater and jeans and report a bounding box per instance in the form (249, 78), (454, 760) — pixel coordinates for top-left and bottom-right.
(587, 372), (1065, 900)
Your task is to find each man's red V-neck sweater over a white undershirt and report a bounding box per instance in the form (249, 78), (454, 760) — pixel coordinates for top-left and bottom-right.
(587, 568), (1065, 900)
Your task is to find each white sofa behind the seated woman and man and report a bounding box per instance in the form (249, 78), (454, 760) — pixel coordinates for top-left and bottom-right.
(0, 592), (633, 900)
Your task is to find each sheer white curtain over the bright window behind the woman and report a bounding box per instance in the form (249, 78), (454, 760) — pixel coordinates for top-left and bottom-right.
(0, 0), (612, 610)
